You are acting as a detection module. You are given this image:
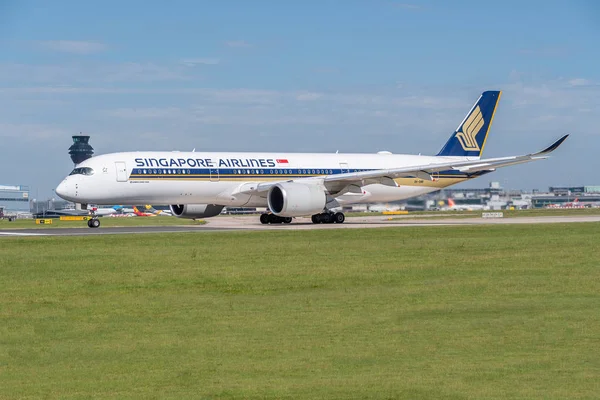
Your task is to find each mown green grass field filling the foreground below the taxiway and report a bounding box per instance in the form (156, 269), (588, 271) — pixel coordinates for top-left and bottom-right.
(0, 223), (600, 399)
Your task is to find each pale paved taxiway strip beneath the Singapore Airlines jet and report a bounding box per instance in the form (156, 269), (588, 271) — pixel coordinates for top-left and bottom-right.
(0, 215), (600, 238)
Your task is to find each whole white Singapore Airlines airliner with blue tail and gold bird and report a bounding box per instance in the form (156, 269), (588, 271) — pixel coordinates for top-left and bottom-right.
(56, 91), (568, 228)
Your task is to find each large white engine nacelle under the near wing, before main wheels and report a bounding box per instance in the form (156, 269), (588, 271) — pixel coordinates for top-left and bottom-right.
(267, 182), (327, 217)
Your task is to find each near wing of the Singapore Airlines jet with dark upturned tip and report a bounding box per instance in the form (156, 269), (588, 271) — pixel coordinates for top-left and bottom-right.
(236, 135), (569, 194)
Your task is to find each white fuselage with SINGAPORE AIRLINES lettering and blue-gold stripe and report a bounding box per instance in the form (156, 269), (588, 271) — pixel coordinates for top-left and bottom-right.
(56, 152), (474, 207)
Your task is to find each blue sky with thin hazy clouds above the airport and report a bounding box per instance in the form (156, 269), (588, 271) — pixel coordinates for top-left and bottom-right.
(0, 0), (600, 198)
